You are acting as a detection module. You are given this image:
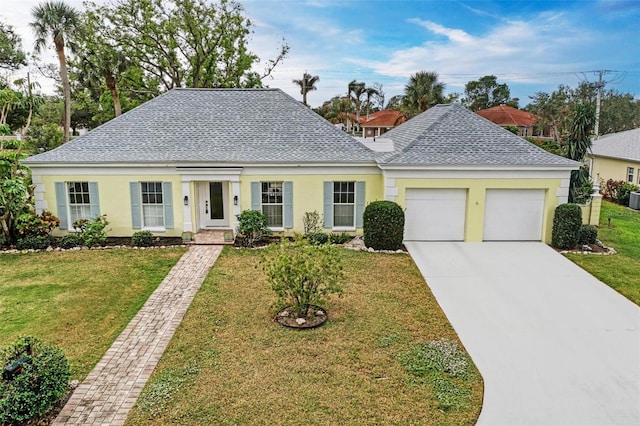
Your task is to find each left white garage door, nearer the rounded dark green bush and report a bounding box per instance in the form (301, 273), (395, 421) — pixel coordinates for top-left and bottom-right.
(404, 189), (467, 241)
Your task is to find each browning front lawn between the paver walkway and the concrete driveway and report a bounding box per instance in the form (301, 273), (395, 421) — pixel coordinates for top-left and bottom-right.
(127, 248), (482, 425)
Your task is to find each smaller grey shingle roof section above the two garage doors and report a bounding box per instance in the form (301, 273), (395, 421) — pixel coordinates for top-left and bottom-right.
(378, 104), (578, 168)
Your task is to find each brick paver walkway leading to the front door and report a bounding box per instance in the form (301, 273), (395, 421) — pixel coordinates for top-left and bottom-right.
(53, 246), (222, 425)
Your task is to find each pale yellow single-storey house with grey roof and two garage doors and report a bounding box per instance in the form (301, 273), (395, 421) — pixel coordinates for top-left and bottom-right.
(25, 89), (578, 241)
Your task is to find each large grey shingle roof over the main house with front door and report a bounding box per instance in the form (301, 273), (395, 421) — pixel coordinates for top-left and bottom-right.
(25, 89), (374, 164)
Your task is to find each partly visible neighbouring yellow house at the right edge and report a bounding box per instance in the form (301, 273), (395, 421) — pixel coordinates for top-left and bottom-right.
(589, 128), (640, 185)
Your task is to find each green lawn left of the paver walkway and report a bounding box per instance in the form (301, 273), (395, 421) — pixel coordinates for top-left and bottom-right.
(0, 248), (184, 380)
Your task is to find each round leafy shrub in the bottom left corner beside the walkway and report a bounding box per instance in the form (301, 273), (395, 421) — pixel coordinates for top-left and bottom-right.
(0, 336), (70, 424)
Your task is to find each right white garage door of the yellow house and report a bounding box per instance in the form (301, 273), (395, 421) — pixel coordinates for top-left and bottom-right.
(483, 189), (545, 241)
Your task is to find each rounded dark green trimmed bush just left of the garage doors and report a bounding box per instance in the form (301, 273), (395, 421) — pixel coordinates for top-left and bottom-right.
(362, 201), (404, 250)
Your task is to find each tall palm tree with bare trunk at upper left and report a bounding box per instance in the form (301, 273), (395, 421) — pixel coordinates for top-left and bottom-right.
(29, 1), (78, 142)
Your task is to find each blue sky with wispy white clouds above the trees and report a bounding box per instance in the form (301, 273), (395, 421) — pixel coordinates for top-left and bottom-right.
(0, 0), (640, 107)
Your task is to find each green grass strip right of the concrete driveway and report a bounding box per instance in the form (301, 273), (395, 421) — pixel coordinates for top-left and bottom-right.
(566, 201), (640, 305)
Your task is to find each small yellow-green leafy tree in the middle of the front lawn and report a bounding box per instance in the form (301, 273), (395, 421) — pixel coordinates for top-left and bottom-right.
(262, 238), (343, 318)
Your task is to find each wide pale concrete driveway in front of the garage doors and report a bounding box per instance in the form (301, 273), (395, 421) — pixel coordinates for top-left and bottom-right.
(405, 242), (640, 425)
